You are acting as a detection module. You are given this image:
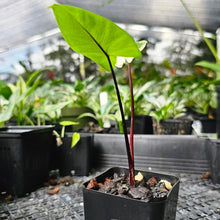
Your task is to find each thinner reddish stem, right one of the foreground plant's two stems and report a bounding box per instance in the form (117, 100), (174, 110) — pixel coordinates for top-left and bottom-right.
(128, 63), (134, 166)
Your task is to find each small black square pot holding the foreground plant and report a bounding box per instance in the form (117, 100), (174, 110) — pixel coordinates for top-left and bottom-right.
(83, 167), (179, 220)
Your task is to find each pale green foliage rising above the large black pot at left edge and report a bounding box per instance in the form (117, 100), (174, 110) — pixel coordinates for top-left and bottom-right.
(0, 70), (68, 126)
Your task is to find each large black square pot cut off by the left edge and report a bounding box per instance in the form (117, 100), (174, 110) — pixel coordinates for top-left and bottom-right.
(0, 126), (53, 196)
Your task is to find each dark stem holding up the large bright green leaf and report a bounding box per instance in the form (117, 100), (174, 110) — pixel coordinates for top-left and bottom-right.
(106, 55), (135, 186)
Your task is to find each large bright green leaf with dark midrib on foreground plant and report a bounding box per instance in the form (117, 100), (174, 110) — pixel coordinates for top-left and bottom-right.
(50, 4), (141, 71)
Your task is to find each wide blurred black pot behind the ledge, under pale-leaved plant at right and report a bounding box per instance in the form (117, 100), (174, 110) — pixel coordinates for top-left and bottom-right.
(153, 119), (192, 135)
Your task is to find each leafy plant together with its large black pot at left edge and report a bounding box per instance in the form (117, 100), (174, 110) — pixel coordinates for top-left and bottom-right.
(0, 71), (64, 196)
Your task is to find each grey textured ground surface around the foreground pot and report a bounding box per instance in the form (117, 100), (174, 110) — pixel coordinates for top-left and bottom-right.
(0, 172), (220, 220)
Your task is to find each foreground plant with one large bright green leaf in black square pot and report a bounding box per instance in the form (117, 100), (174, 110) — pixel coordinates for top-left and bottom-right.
(51, 4), (179, 219)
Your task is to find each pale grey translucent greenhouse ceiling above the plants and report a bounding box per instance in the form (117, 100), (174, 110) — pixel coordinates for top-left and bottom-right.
(0, 0), (220, 52)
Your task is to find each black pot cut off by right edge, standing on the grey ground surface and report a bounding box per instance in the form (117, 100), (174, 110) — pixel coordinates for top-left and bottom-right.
(206, 139), (220, 183)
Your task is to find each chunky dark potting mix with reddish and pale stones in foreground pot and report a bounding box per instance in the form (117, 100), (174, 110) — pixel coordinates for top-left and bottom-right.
(87, 173), (172, 202)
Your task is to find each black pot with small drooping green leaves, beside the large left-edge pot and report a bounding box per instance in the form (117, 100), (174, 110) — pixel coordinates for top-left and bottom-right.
(52, 132), (93, 176)
